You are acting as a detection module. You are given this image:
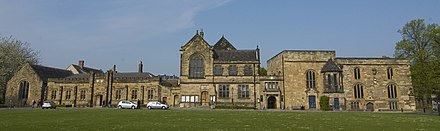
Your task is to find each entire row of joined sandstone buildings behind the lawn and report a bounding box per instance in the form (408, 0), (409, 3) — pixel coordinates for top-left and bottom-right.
(6, 32), (415, 111)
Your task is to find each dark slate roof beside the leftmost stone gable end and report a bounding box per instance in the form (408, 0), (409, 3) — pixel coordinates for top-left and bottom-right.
(30, 65), (73, 80)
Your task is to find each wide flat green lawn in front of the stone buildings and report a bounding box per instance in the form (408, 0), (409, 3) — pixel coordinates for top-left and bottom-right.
(0, 109), (440, 131)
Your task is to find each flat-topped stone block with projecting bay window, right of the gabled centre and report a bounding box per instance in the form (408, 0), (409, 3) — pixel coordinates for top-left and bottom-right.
(267, 50), (415, 111)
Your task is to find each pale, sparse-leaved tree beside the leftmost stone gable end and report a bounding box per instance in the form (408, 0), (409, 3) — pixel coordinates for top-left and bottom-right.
(0, 36), (39, 103)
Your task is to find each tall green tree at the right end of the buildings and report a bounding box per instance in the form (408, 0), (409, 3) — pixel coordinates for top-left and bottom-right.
(394, 19), (438, 108)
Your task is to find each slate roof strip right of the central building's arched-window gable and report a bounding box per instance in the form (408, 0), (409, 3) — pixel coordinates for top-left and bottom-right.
(214, 50), (258, 61)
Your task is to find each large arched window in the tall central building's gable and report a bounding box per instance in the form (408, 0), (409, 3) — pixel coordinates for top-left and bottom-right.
(189, 55), (205, 78)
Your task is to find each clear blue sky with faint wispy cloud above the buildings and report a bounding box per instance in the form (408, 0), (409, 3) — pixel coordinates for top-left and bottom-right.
(0, 0), (440, 75)
